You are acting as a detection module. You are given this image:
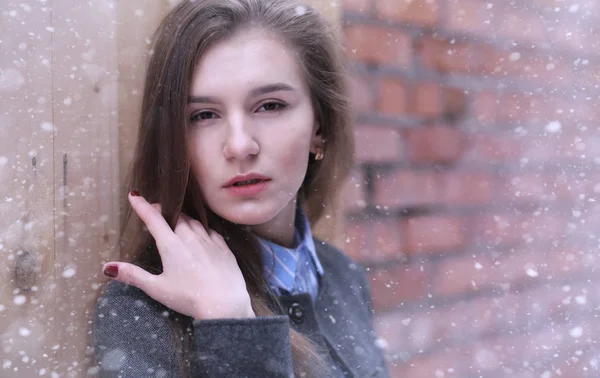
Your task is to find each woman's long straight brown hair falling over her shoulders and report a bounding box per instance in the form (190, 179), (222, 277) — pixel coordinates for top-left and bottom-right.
(123, 0), (354, 378)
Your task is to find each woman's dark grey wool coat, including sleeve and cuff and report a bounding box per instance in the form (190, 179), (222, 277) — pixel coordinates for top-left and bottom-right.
(93, 240), (388, 378)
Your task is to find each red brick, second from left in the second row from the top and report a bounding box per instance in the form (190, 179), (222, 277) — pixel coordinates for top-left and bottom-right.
(417, 37), (474, 73)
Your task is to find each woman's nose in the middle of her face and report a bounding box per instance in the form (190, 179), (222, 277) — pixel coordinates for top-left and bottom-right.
(223, 116), (260, 160)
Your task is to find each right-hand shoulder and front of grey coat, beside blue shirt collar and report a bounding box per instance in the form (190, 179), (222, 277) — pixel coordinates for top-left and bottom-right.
(274, 239), (382, 378)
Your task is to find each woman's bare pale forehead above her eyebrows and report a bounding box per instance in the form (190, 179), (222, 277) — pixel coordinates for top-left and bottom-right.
(191, 30), (306, 95)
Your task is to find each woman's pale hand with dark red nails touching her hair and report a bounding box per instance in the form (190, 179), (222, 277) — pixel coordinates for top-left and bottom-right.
(104, 192), (255, 319)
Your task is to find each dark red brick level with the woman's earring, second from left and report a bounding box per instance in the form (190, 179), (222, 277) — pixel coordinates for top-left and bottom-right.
(404, 126), (465, 164)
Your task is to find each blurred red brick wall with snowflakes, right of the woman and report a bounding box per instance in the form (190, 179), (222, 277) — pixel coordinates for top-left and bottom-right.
(342, 0), (600, 378)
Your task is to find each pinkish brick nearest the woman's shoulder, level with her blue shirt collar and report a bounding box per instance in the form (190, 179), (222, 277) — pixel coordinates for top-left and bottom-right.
(344, 218), (406, 263)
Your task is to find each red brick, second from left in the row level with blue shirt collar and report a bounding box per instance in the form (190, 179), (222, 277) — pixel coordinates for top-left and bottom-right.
(402, 216), (466, 255)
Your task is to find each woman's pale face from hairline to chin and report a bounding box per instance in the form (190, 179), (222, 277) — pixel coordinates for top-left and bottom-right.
(186, 30), (320, 230)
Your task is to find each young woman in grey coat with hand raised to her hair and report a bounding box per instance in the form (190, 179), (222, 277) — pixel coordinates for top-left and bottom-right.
(94, 0), (388, 378)
